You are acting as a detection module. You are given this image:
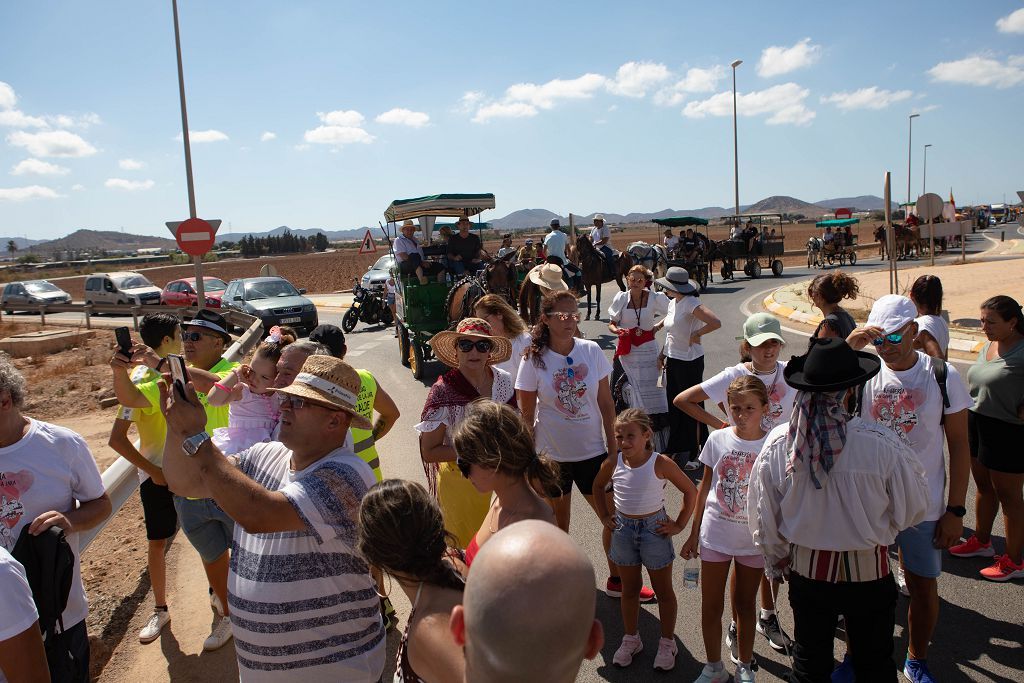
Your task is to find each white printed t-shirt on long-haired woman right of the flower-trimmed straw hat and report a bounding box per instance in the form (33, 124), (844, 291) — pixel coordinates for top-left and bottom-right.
(515, 339), (611, 463)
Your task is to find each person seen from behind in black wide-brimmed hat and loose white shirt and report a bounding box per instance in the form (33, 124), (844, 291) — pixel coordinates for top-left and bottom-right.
(748, 338), (929, 683)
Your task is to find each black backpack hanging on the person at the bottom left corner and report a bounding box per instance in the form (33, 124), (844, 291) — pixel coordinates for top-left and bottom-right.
(11, 524), (75, 680)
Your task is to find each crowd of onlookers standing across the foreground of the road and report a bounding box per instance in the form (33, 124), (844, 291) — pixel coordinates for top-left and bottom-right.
(0, 268), (1024, 683)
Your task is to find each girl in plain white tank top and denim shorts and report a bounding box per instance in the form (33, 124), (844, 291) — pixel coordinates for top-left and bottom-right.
(594, 408), (696, 671)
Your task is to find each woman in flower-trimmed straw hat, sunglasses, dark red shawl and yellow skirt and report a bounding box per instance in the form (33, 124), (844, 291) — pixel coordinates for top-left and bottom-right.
(415, 317), (515, 548)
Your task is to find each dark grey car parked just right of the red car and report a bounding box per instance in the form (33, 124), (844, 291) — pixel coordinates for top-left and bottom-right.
(221, 276), (319, 334)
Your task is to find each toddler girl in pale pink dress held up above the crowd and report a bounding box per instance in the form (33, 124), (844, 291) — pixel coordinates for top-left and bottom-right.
(207, 327), (295, 455)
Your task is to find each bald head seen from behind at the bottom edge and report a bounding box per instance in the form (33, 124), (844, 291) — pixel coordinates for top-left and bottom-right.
(452, 520), (604, 683)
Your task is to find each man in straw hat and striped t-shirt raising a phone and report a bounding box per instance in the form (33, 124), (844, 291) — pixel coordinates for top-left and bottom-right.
(161, 355), (386, 682)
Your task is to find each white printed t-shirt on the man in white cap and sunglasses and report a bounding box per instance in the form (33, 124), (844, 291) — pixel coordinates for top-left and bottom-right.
(861, 351), (974, 521)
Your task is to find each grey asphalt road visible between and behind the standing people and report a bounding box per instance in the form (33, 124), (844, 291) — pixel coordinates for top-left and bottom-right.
(321, 242), (1024, 682)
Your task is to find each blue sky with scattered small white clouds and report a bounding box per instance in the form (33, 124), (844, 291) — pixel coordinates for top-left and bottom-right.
(0, 0), (1024, 239)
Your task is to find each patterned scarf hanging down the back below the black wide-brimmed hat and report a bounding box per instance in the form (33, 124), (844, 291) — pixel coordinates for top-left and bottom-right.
(786, 389), (849, 488)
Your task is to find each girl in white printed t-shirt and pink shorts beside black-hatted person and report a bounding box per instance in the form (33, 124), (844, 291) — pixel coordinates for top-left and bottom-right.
(680, 375), (768, 683)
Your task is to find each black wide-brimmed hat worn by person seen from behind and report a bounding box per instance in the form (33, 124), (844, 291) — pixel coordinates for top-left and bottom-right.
(783, 337), (882, 393)
